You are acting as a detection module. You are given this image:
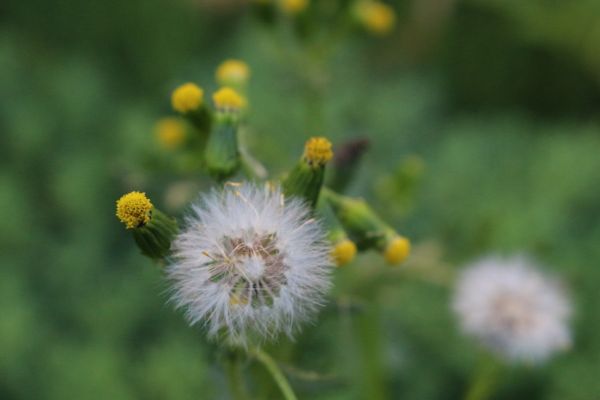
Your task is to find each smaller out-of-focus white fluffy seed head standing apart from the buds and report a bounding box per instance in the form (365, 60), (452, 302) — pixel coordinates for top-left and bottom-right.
(453, 257), (571, 362)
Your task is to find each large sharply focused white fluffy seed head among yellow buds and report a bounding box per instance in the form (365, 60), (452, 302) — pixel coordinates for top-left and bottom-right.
(167, 183), (332, 345)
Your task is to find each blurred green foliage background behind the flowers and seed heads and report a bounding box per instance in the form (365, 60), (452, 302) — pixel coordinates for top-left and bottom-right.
(0, 0), (600, 400)
